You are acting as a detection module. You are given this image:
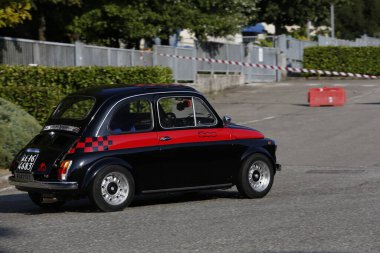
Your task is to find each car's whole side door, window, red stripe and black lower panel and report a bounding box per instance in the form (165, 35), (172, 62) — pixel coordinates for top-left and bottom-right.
(156, 95), (233, 189)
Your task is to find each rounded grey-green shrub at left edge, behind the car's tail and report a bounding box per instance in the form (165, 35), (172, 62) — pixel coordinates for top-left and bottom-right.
(0, 98), (41, 167)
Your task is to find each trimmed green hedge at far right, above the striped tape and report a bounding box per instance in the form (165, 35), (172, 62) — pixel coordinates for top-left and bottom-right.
(303, 47), (380, 76)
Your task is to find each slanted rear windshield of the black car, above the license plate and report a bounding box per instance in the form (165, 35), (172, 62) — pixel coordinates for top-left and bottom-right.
(52, 96), (95, 120)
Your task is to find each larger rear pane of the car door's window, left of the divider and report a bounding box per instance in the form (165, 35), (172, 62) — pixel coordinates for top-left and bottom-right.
(158, 97), (195, 128)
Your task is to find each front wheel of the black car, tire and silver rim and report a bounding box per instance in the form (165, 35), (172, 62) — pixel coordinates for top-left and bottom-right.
(236, 154), (274, 199)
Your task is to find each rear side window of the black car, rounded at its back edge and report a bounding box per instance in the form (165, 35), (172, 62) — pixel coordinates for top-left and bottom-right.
(109, 99), (153, 134)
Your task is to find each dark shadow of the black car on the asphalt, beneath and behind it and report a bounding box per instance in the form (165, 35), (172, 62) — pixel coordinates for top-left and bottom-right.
(0, 190), (242, 215)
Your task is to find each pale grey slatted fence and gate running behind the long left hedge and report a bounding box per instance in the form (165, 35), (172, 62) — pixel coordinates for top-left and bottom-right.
(0, 37), (276, 82)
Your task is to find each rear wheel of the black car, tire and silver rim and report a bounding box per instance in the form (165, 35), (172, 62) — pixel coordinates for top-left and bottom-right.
(89, 165), (135, 212)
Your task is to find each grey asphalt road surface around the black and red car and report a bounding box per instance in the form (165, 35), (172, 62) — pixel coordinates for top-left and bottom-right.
(0, 80), (380, 253)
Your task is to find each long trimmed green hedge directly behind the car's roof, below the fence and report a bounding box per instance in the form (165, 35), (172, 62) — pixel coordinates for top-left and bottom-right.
(0, 65), (173, 123)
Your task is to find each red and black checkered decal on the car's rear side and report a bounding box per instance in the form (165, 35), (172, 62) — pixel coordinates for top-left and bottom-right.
(69, 136), (113, 154)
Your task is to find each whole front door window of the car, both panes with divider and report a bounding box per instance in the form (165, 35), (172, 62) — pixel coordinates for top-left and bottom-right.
(158, 97), (217, 128)
